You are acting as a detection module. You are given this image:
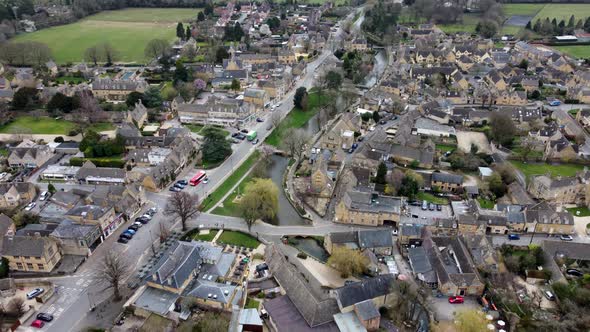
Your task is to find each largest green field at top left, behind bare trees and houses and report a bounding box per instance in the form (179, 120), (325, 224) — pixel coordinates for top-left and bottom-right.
(12, 8), (199, 64)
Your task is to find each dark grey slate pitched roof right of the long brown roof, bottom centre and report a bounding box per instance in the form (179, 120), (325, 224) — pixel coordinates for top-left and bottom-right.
(334, 274), (395, 308)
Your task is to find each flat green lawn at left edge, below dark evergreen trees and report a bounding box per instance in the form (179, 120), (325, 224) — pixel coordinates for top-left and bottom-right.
(0, 116), (76, 135)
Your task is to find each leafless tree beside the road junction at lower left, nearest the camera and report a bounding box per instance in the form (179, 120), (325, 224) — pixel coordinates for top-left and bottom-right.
(96, 251), (131, 301)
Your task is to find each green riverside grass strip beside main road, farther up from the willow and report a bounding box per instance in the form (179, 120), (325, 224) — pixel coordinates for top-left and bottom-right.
(265, 91), (329, 147)
